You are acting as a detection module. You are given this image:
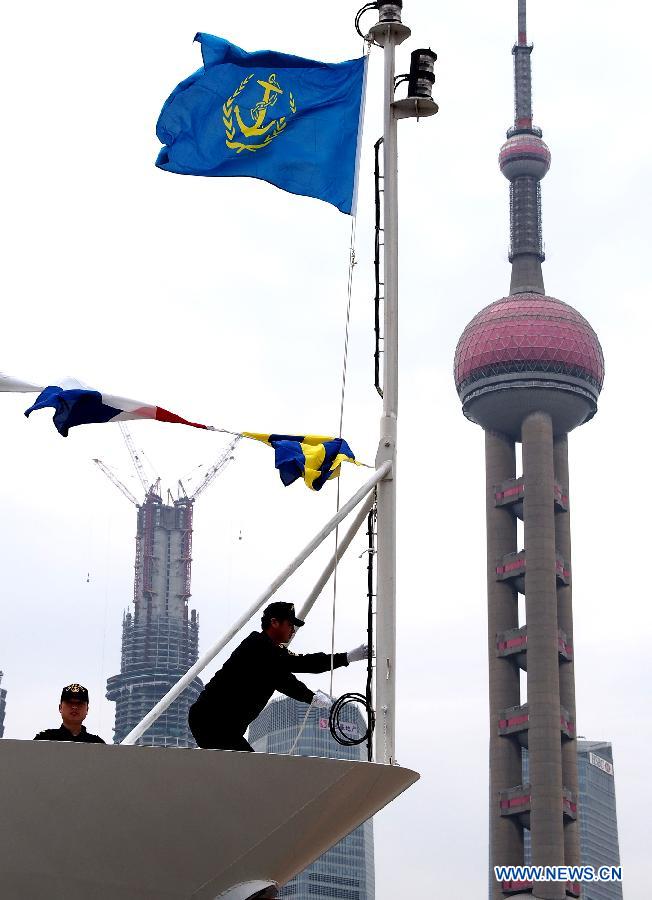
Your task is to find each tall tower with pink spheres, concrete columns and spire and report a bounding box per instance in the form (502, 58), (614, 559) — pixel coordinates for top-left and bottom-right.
(455, 0), (604, 900)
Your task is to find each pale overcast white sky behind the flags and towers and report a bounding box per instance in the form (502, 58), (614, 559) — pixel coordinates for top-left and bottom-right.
(0, 0), (652, 900)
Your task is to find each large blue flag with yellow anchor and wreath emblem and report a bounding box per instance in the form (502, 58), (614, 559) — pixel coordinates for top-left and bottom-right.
(156, 34), (366, 214)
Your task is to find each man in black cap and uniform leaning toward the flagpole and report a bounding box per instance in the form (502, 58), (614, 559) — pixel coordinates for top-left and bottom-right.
(188, 602), (367, 750)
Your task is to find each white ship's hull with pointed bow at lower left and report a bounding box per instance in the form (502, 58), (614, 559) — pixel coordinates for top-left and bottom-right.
(0, 740), (419, 900)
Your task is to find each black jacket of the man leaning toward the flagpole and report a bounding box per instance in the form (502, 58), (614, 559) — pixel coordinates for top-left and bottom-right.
(193, 631), (348, 734)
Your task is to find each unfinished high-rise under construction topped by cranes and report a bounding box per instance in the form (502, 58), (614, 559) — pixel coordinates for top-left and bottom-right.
(106, 488), (203, 747)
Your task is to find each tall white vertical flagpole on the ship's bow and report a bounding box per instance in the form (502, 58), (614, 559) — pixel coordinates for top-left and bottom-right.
(370, 3), (410, 765)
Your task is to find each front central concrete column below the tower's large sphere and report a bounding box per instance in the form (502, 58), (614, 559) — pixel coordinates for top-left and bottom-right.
(522, 412), (566, 900)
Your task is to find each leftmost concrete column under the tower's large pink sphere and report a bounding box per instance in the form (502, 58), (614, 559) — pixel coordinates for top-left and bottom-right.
(485, 431), (523, 900)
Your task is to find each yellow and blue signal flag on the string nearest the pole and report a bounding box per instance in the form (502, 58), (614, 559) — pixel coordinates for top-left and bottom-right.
(243, 431), (360, 491)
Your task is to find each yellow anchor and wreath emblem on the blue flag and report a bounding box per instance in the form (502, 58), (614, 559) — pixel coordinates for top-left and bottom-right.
(222, 72), (297, 153)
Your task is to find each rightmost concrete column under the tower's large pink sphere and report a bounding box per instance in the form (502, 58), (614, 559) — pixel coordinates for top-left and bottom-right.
(554, 434), (582, 866)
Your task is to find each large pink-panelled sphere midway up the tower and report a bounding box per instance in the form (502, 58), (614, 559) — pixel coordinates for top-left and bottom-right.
(455, 293), (604, 440)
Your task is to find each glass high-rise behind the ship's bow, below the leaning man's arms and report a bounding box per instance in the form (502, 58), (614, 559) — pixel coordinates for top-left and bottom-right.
(249, 697), (375, 900)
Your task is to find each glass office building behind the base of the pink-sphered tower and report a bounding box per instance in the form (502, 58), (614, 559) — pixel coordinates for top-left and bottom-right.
(523, 739), (623, 900)
